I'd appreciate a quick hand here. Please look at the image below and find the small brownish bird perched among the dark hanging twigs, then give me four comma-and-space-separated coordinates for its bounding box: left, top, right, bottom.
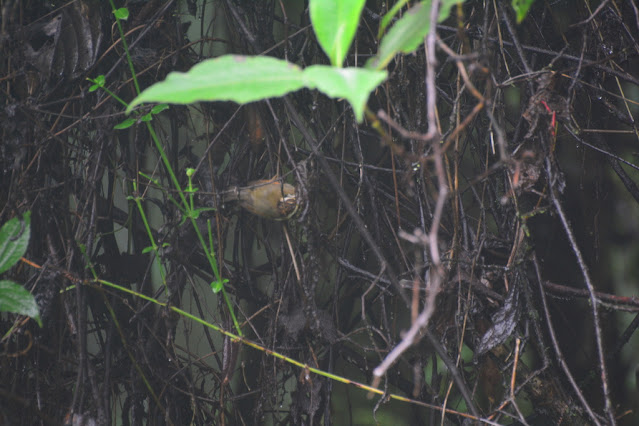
223, 178, 299, 220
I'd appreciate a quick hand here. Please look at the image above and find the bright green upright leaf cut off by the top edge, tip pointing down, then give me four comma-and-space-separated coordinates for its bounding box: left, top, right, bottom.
309, 0, 366, 67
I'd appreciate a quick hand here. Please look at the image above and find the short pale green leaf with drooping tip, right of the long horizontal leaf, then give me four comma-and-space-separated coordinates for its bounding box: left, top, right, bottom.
304, 65, 387, 122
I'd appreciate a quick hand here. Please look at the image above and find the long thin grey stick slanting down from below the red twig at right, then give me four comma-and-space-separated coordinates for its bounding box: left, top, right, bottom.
546, 158, 616, 425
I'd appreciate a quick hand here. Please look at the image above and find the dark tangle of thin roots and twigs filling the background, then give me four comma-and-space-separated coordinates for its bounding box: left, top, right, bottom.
0, 0, 639, 425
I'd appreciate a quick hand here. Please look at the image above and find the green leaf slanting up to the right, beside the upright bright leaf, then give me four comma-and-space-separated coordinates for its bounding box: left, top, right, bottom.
366, 0, 461, 69
